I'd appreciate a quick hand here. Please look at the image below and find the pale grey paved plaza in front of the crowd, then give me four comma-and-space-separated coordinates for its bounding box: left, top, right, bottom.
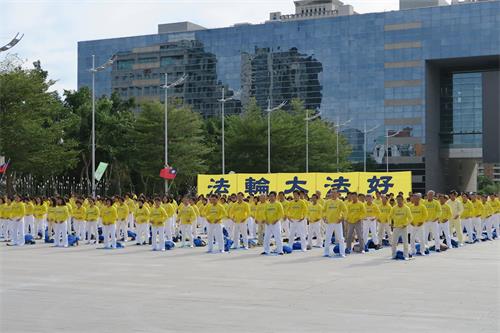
0, 241, 500, 333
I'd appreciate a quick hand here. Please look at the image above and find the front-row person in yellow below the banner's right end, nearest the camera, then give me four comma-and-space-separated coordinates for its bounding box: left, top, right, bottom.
390, 195, 413, 260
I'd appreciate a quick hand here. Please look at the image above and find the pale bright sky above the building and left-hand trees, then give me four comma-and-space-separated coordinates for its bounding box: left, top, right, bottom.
0, 0, 399, 92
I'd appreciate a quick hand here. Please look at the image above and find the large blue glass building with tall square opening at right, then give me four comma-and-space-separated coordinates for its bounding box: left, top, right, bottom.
78, 0, 500, 191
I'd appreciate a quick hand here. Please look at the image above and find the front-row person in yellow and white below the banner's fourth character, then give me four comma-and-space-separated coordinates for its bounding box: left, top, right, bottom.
323, 190, 347, 257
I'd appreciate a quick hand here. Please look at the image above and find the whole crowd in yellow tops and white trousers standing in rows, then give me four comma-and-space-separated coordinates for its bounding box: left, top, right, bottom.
0, 190, 500, 260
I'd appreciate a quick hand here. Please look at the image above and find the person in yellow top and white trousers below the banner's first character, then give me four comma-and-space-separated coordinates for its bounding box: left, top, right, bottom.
205, 194, 227, 253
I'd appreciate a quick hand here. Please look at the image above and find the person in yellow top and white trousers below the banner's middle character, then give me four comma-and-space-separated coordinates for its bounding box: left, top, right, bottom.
286, 191, 307, 251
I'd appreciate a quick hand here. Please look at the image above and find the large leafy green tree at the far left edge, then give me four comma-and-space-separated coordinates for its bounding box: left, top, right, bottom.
0, 62, 78, 192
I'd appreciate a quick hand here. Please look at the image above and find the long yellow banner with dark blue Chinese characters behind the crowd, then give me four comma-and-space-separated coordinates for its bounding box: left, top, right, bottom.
198, 171, 412, 196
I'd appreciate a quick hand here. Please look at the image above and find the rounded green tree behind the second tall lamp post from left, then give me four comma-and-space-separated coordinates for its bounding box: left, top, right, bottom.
132, 101, 210, 193
